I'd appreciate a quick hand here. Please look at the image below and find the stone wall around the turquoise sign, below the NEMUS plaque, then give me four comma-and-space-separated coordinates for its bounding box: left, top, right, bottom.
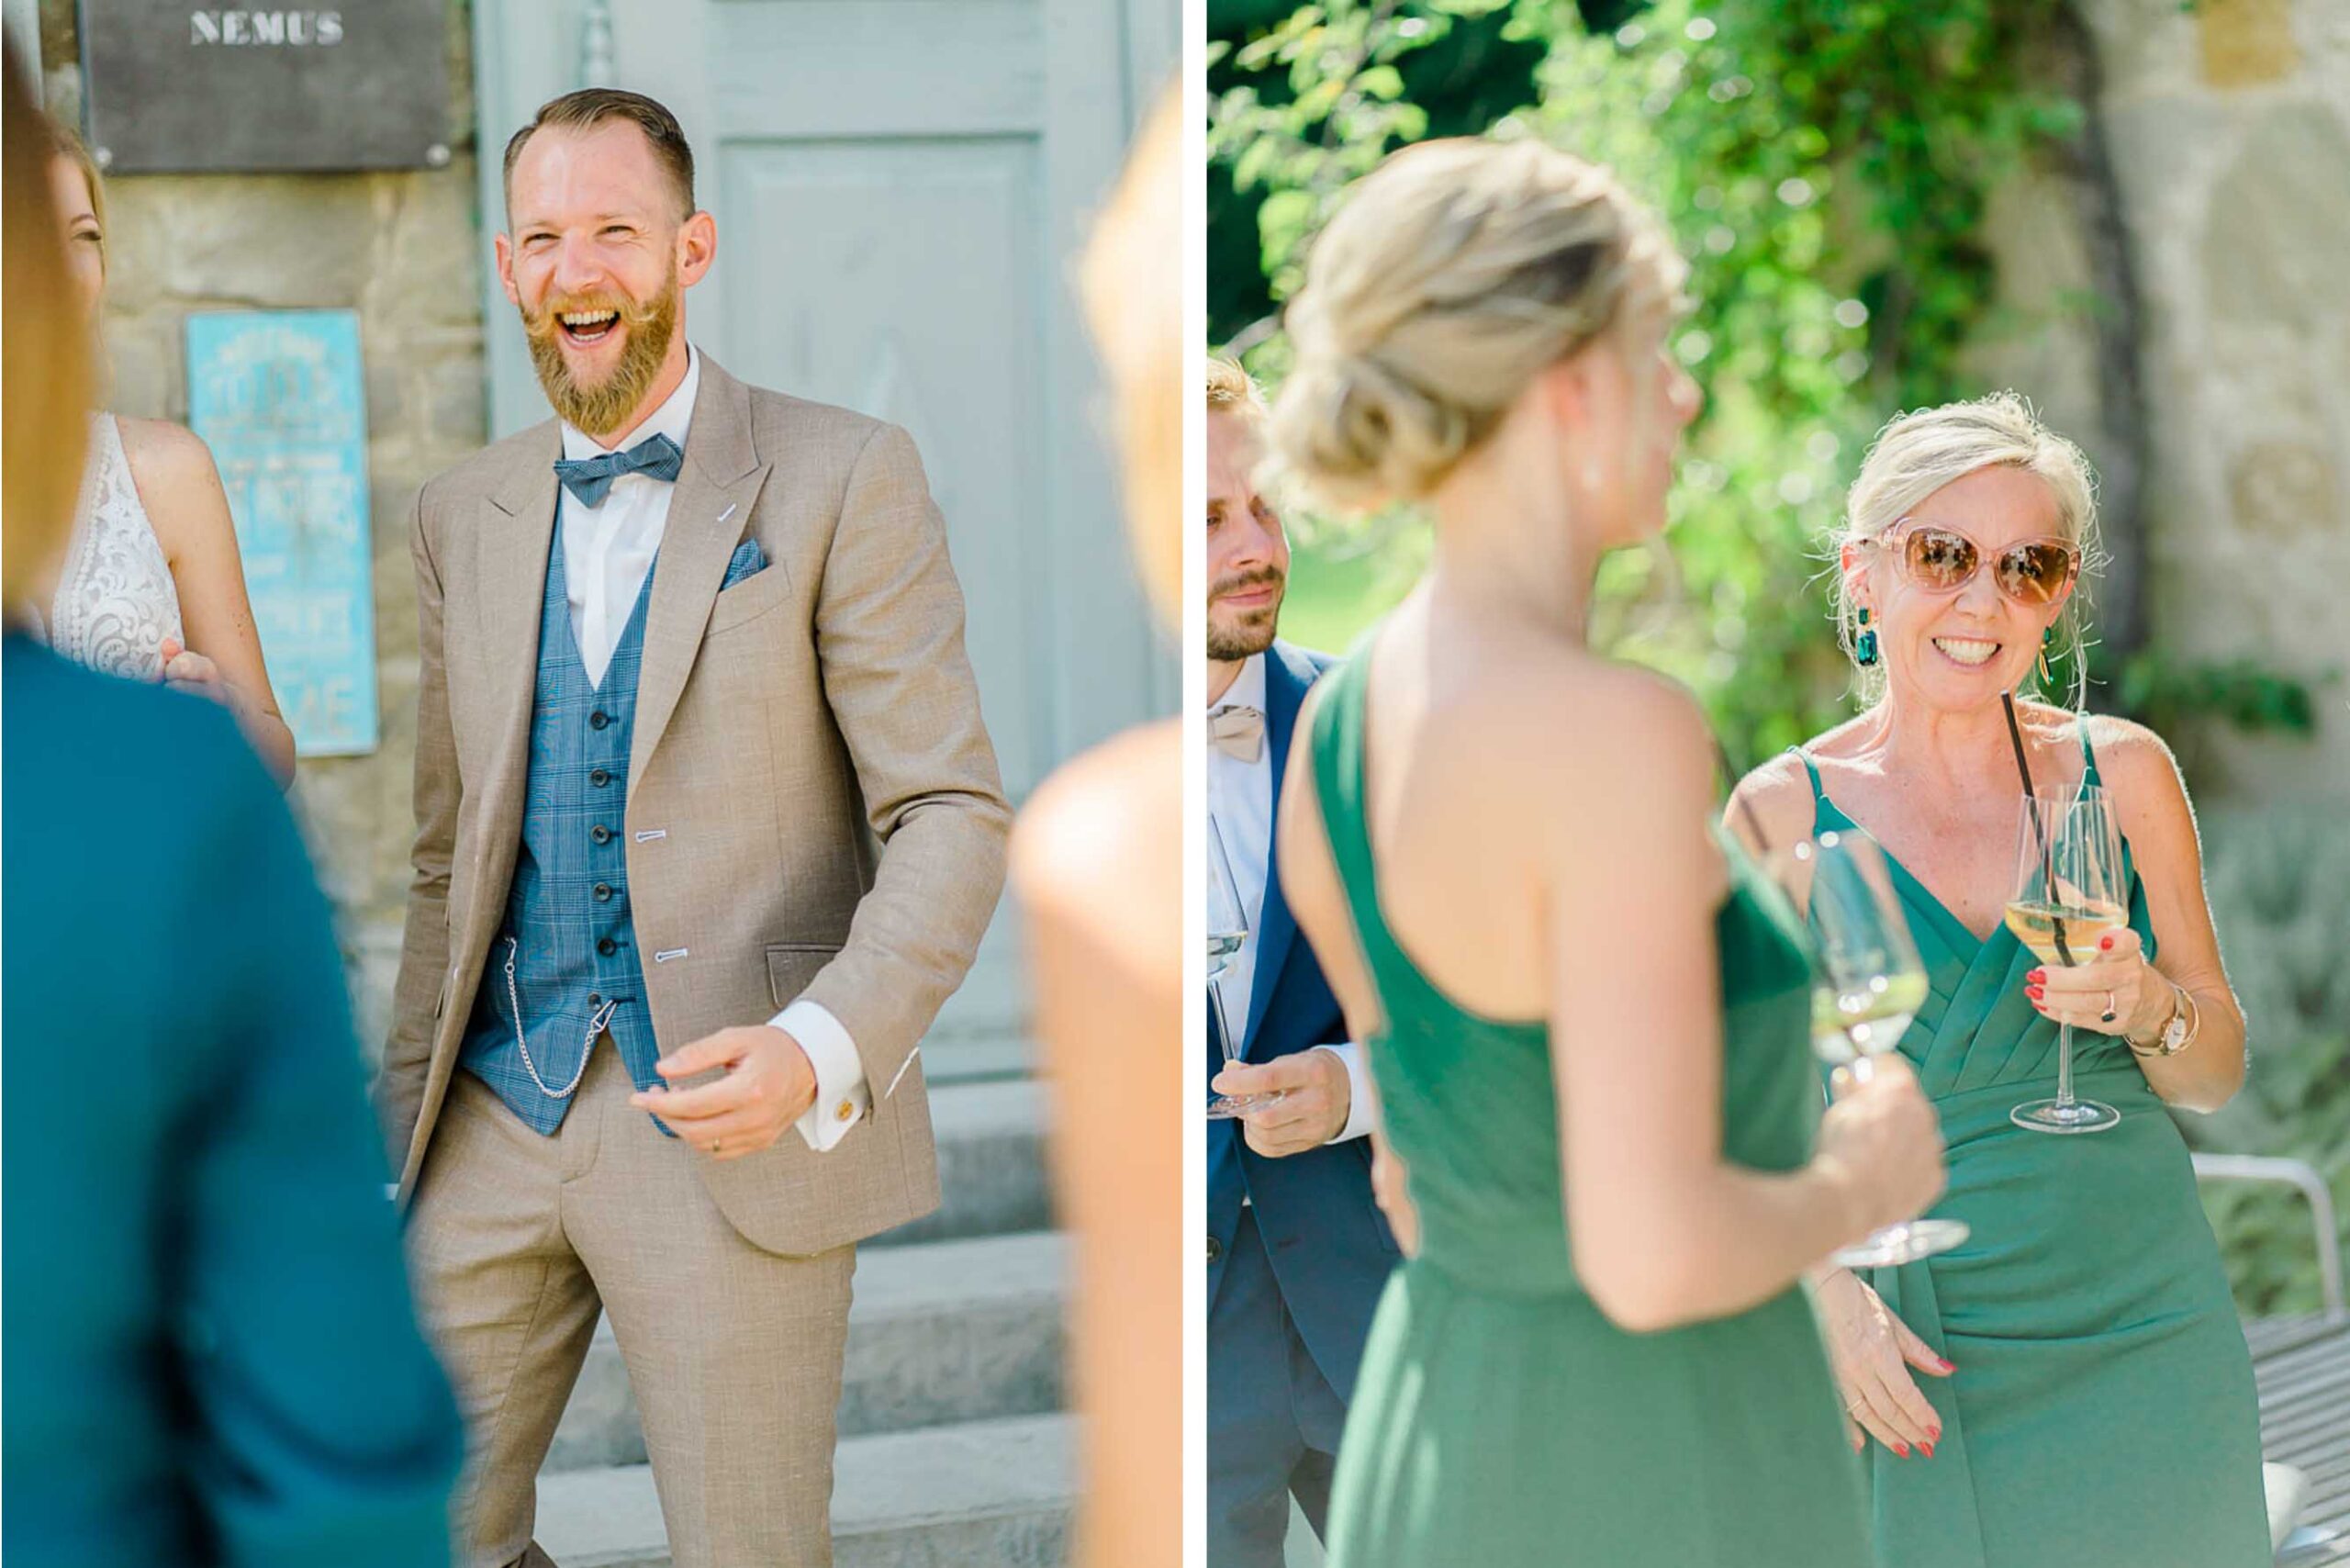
40, 0, 488, 1051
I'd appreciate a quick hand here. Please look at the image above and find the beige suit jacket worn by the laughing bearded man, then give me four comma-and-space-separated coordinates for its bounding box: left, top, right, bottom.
378, 355, 1011, 1255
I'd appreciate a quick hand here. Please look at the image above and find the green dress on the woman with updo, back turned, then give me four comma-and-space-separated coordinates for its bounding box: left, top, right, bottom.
1311, 655, 1868, 1568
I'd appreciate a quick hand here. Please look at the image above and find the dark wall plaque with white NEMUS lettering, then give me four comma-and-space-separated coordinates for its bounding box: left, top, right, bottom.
80, 0, 449, 174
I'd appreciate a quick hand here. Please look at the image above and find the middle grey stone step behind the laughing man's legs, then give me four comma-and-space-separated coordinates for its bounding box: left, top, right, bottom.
545, 1232, 1069, 1472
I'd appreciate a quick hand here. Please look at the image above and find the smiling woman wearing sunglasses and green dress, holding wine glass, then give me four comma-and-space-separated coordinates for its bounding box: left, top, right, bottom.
1729, 393, 2270, 1568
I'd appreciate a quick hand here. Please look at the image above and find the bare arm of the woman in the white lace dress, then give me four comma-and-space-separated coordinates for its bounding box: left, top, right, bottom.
120, 419, 294, 790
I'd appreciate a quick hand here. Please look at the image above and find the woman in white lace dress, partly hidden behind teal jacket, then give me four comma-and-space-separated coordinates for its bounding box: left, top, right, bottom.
28, 120, 294, 788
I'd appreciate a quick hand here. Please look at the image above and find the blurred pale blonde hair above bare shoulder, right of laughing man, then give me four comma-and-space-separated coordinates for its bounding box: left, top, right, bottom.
1079, 87, 1184, 625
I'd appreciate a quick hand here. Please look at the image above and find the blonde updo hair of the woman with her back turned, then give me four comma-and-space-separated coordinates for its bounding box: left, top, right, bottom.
1271, 139, 1687, 510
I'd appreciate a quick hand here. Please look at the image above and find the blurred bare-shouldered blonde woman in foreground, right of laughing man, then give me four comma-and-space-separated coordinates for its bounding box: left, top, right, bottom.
1013, 89, 1192, 1568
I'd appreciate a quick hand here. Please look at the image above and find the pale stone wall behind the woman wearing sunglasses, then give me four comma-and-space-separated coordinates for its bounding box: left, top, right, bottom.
1979, 0, 2350, 804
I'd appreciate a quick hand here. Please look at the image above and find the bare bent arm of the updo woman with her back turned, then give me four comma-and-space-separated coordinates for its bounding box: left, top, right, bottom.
1528, 672, 1942, 1330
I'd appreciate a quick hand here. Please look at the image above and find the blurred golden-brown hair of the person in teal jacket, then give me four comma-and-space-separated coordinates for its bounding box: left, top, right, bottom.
0, 47, 89, 613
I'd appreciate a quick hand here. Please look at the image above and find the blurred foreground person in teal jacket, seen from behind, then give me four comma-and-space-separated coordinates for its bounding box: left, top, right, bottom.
0, 50, 461, 1568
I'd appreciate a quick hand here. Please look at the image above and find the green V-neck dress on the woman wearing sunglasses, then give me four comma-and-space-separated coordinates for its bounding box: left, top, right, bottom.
1797, 734, 2270, 1568
